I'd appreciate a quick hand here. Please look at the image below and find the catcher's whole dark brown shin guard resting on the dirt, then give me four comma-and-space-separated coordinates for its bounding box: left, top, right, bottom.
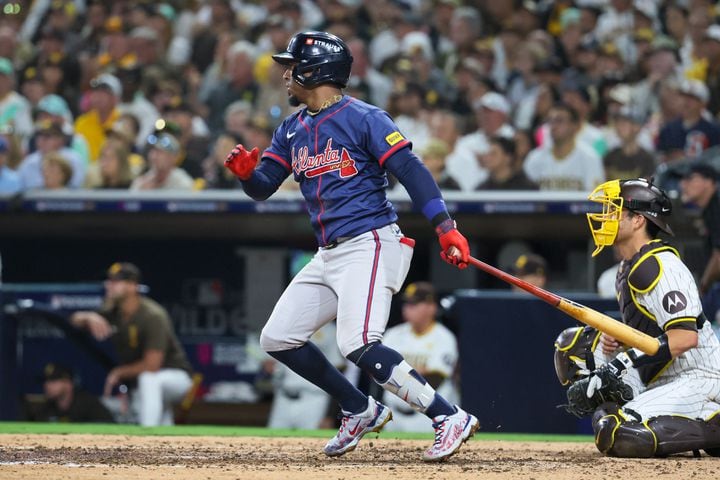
593, 412, 720, 458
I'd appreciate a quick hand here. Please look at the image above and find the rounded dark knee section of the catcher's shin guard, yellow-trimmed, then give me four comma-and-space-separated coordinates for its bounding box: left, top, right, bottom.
593, 412, 657, 458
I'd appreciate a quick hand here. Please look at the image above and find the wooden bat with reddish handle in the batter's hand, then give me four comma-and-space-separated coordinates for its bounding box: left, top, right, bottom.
469, 256, 660, 355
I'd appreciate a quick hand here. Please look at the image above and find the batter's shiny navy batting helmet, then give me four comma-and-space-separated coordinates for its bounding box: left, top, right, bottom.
273, 31, 353, 88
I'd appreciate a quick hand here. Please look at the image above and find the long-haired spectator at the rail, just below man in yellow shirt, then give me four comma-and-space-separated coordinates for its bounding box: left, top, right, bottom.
85, 141, 135, 189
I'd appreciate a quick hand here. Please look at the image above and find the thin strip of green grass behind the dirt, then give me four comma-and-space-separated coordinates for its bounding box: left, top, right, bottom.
0, 422, 593, 442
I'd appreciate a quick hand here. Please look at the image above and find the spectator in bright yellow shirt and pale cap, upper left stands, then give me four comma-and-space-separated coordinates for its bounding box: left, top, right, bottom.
75, 73, 122, 162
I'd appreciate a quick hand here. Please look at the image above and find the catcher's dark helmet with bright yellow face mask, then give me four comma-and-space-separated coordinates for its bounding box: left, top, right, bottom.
587, 178, 673, 257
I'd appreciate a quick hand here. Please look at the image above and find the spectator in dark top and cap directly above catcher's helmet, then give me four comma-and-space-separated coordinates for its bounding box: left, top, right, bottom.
603, 105, 656, 179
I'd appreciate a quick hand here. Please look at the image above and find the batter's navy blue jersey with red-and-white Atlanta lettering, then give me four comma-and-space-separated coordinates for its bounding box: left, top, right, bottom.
263, 95, 411, 246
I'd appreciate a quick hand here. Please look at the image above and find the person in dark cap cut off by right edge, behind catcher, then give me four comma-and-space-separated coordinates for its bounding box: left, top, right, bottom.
680, 163, 720, 295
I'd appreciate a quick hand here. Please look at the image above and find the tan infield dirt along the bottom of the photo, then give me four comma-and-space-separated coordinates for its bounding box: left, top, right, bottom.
0, 435, 720, 480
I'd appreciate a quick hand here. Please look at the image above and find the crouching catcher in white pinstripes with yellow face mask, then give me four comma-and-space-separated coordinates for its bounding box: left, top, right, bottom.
555, 178, 720, 457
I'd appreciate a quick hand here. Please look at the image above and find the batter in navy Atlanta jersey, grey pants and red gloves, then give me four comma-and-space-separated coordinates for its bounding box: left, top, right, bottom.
225, 32, 479, 461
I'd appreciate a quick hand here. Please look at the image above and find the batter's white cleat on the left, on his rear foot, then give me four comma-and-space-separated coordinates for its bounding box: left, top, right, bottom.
323, 397, 392, 457
